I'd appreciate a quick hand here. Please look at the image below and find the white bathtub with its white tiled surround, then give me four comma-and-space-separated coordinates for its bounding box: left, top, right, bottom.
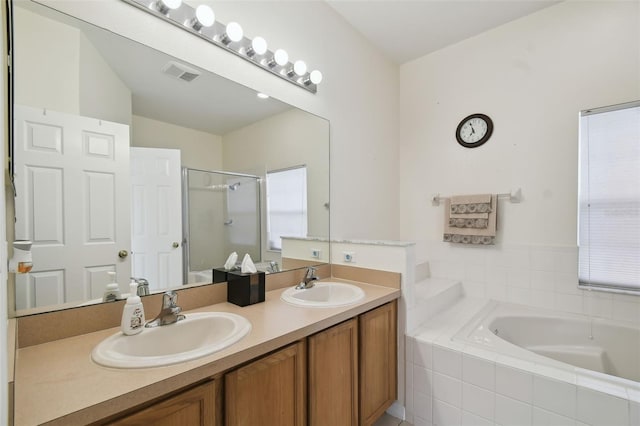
405, 291, 640, 426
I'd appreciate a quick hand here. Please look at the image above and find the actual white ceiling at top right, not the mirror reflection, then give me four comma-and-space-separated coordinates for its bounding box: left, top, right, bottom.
325, 0, 559, 64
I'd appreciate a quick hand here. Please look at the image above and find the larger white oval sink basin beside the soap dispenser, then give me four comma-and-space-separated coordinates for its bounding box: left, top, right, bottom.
91, 312, 251, 368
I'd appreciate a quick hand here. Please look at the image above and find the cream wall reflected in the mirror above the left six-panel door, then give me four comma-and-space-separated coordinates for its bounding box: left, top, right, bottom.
14, 7, 131, 124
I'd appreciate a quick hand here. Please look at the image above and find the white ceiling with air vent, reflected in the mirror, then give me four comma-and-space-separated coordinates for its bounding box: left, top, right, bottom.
84, 26, 292, 135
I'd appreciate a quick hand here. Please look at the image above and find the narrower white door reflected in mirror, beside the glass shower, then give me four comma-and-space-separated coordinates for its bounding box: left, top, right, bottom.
131, 147, 183, 290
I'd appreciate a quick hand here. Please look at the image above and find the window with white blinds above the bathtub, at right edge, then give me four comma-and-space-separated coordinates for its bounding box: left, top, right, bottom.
578, 101, 640, 292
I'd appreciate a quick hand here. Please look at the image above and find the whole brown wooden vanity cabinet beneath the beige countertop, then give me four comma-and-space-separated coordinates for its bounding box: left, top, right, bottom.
99, 301, 397, 426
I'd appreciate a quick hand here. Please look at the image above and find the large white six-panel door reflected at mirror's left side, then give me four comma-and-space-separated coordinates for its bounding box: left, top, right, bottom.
14, 105, 131, 309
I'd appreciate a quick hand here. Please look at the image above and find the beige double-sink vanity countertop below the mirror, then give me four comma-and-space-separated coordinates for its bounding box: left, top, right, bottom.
14, 280, 400, 426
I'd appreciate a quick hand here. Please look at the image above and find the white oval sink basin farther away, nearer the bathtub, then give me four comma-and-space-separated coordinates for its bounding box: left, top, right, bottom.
281, 281, 364, 308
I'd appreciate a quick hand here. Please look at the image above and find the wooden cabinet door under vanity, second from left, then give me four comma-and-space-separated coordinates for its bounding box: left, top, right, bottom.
225, 341, 307, 426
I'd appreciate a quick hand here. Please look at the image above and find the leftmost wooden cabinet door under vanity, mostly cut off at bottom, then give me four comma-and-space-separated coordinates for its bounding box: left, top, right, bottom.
111, 380, 219, 426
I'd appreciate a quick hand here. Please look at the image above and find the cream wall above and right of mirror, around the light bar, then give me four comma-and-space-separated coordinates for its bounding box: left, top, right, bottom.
35, 0, 399, 239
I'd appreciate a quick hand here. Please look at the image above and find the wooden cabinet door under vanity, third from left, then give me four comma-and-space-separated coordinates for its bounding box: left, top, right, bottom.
308, 318, 358, 426
